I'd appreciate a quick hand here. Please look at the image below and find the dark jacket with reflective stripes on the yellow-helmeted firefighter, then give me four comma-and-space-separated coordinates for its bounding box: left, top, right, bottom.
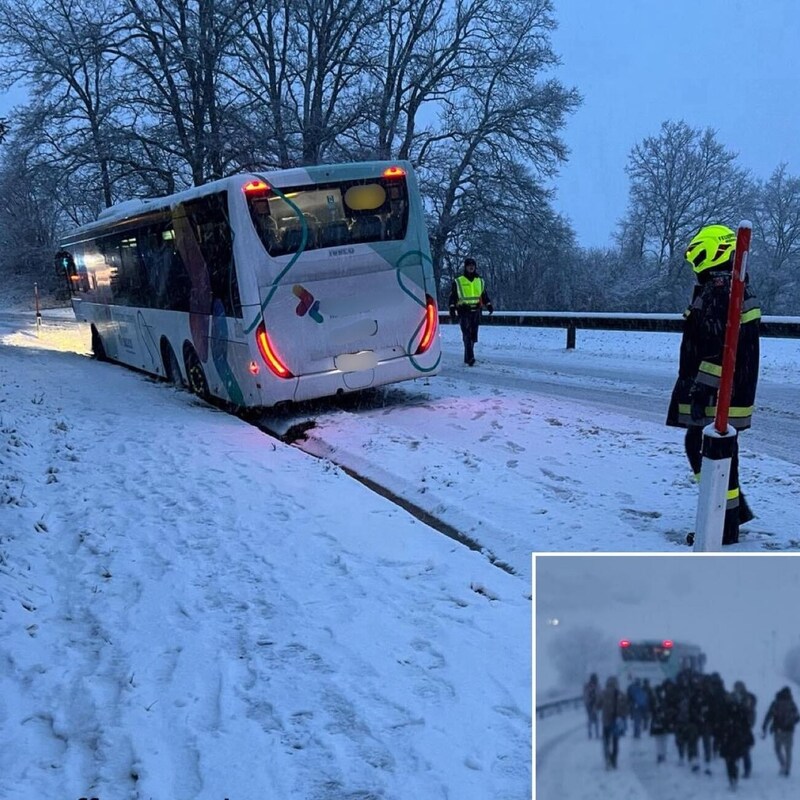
667, 270, 761, 430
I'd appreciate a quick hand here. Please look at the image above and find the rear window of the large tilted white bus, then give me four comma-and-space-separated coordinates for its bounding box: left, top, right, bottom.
247, 178, 408, 256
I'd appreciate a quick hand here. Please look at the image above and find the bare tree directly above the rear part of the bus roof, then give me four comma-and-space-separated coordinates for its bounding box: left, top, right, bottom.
229, 0, 388, 167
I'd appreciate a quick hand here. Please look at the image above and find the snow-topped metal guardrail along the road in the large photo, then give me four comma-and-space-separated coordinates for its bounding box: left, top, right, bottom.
439, 311, 800, 350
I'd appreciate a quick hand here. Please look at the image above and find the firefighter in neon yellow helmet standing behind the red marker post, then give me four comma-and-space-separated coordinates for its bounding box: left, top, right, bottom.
667, 225, 761, 544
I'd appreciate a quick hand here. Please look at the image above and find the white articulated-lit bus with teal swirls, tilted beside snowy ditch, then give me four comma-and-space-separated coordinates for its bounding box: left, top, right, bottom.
56, 161, 441, 409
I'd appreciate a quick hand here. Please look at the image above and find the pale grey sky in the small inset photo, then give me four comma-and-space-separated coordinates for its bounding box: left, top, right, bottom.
536, 554, 800, 692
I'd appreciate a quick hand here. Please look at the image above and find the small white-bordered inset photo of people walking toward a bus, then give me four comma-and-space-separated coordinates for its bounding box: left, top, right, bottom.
533, 553, 800, 800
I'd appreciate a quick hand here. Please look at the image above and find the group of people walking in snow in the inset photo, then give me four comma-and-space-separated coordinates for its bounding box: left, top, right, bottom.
583, 670, 800, 789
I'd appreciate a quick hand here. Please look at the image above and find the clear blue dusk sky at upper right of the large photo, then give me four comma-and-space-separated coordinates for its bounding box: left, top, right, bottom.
553, 0, 800, 246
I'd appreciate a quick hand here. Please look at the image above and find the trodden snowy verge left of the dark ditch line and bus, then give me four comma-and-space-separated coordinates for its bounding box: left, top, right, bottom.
0, 310, 531, 800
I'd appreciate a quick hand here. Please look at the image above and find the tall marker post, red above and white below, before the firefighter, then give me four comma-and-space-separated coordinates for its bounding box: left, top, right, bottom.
694, 220, 753, 552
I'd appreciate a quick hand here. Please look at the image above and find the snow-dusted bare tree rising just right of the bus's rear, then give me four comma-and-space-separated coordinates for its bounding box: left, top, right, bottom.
417, 0, 580, 296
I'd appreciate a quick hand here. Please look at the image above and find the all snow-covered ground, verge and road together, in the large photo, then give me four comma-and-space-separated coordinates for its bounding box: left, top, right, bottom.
0, 310, 800, 800
